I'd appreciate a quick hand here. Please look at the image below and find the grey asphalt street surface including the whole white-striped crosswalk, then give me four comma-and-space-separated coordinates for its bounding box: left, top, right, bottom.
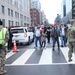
5, 40, 75, 75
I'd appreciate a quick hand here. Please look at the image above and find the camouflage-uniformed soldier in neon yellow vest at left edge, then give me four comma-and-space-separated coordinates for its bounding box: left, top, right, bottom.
0, 20, 9, 74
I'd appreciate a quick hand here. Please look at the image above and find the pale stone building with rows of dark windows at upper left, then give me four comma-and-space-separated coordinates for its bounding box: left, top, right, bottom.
0, 0, 31, 27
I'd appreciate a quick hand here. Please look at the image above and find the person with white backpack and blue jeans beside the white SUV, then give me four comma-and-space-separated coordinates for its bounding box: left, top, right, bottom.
35, 25, 42, 48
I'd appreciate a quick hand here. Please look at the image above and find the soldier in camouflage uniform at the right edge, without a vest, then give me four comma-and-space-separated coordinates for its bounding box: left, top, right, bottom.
67, 19, 75, 62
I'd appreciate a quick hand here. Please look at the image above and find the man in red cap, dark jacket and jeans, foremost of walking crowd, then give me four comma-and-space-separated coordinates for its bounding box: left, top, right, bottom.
51, 24, 60, 51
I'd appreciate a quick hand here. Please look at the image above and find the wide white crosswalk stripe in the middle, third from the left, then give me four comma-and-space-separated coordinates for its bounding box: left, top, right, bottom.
39, 48, 52, 64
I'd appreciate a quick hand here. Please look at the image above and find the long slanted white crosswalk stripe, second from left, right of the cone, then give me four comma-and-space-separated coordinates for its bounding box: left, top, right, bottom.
11, 49, 34, 65
